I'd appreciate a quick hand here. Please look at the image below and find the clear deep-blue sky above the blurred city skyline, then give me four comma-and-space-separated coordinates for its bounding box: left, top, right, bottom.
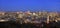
0, 0, 60, 11
